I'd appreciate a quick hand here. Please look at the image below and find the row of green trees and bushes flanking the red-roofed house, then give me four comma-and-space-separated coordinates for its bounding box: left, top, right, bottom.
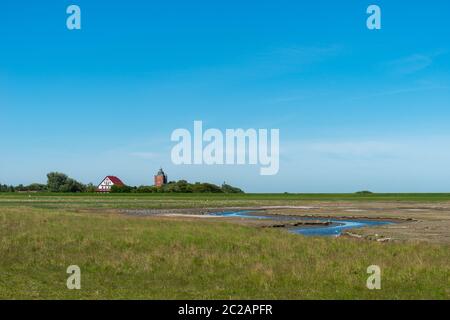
0, 172, 244, 193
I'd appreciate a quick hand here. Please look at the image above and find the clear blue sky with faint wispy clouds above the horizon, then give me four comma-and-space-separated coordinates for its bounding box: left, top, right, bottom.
0, 0, 450, 192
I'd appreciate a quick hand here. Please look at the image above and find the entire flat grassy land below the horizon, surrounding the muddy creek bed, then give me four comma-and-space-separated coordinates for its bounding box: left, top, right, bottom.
0, 194, 450, 299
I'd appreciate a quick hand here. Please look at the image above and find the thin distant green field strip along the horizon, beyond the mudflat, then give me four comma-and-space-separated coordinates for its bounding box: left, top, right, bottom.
0, 193, 450, 209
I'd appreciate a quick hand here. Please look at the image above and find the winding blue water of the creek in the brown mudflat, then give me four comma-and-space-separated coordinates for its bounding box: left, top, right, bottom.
212, 210, 392, 237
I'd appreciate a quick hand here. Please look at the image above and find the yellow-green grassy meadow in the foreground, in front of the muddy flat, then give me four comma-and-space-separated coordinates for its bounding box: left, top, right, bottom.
0, 206, 450, 299
